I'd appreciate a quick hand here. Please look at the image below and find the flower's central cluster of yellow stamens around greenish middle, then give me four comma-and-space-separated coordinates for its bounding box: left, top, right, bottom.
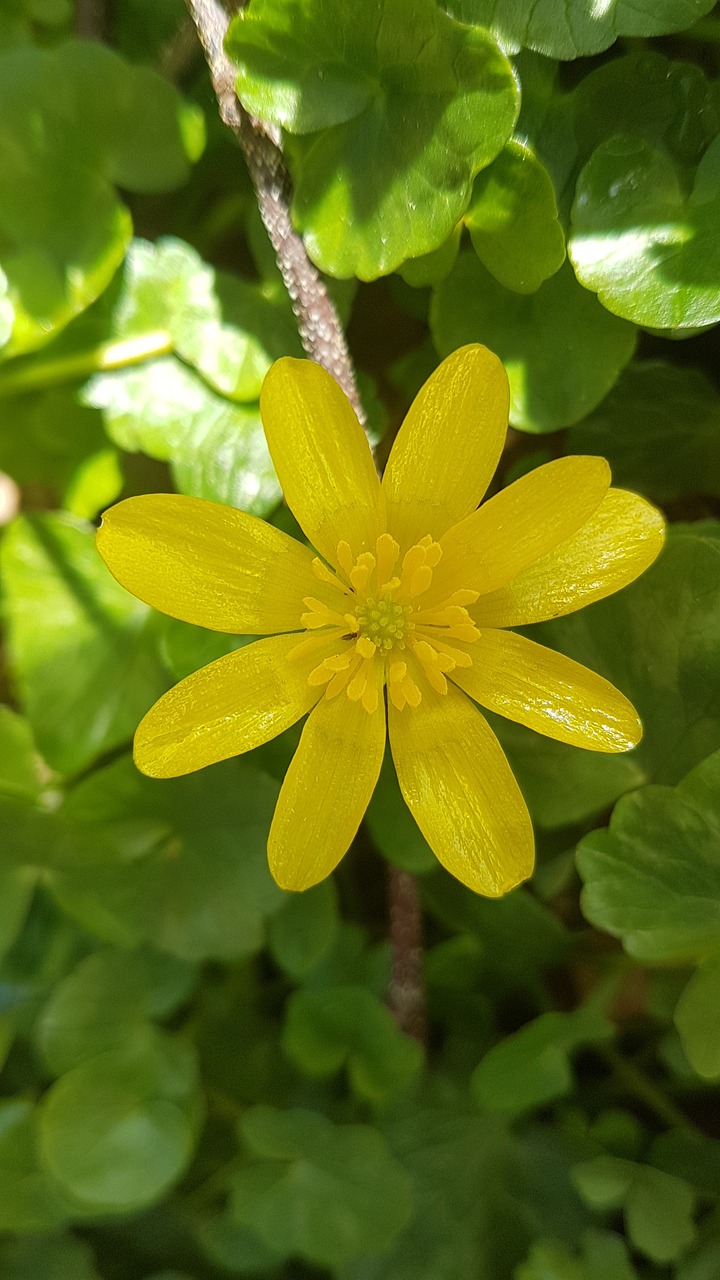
293, 534, 479, 713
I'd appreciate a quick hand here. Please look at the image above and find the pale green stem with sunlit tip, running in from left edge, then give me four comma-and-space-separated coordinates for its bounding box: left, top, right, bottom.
0, 329, 173, 399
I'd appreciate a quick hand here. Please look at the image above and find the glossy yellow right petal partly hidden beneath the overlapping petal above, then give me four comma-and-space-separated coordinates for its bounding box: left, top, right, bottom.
470, 489, 665, 627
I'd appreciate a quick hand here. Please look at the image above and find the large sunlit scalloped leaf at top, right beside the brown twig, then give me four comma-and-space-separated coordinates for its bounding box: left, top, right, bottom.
228, 0, 518, 280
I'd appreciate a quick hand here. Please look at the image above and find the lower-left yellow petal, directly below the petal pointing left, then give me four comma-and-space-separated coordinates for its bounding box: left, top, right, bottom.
135, 635, 325, 778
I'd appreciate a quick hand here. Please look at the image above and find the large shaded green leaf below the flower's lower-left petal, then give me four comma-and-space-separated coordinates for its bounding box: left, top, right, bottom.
51, 758, 282, 960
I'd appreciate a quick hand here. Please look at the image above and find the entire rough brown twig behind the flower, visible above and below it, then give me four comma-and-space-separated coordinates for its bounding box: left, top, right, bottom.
187, 0, 425, 1043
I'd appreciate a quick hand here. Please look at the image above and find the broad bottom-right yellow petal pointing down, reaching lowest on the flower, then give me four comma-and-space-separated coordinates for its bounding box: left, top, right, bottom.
388, 685, 534, 897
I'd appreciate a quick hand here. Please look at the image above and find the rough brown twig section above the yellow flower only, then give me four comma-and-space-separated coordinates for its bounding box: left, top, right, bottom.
187, 0, 365, 422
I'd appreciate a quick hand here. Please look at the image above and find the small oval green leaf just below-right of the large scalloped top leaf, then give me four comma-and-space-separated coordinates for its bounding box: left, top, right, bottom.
464, 141, 565, 293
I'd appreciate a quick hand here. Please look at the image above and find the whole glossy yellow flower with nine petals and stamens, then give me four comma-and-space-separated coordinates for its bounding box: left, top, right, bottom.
97, 346, 664, 897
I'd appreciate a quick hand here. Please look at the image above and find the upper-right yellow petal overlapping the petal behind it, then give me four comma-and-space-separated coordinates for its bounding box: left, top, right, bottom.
433, 457, 610, 593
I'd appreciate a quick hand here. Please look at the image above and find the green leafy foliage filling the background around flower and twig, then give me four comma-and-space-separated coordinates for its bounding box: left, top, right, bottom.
0, 0, 720, 1280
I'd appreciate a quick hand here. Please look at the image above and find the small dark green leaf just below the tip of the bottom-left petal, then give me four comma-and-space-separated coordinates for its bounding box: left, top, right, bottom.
268, 879, 340, 978
